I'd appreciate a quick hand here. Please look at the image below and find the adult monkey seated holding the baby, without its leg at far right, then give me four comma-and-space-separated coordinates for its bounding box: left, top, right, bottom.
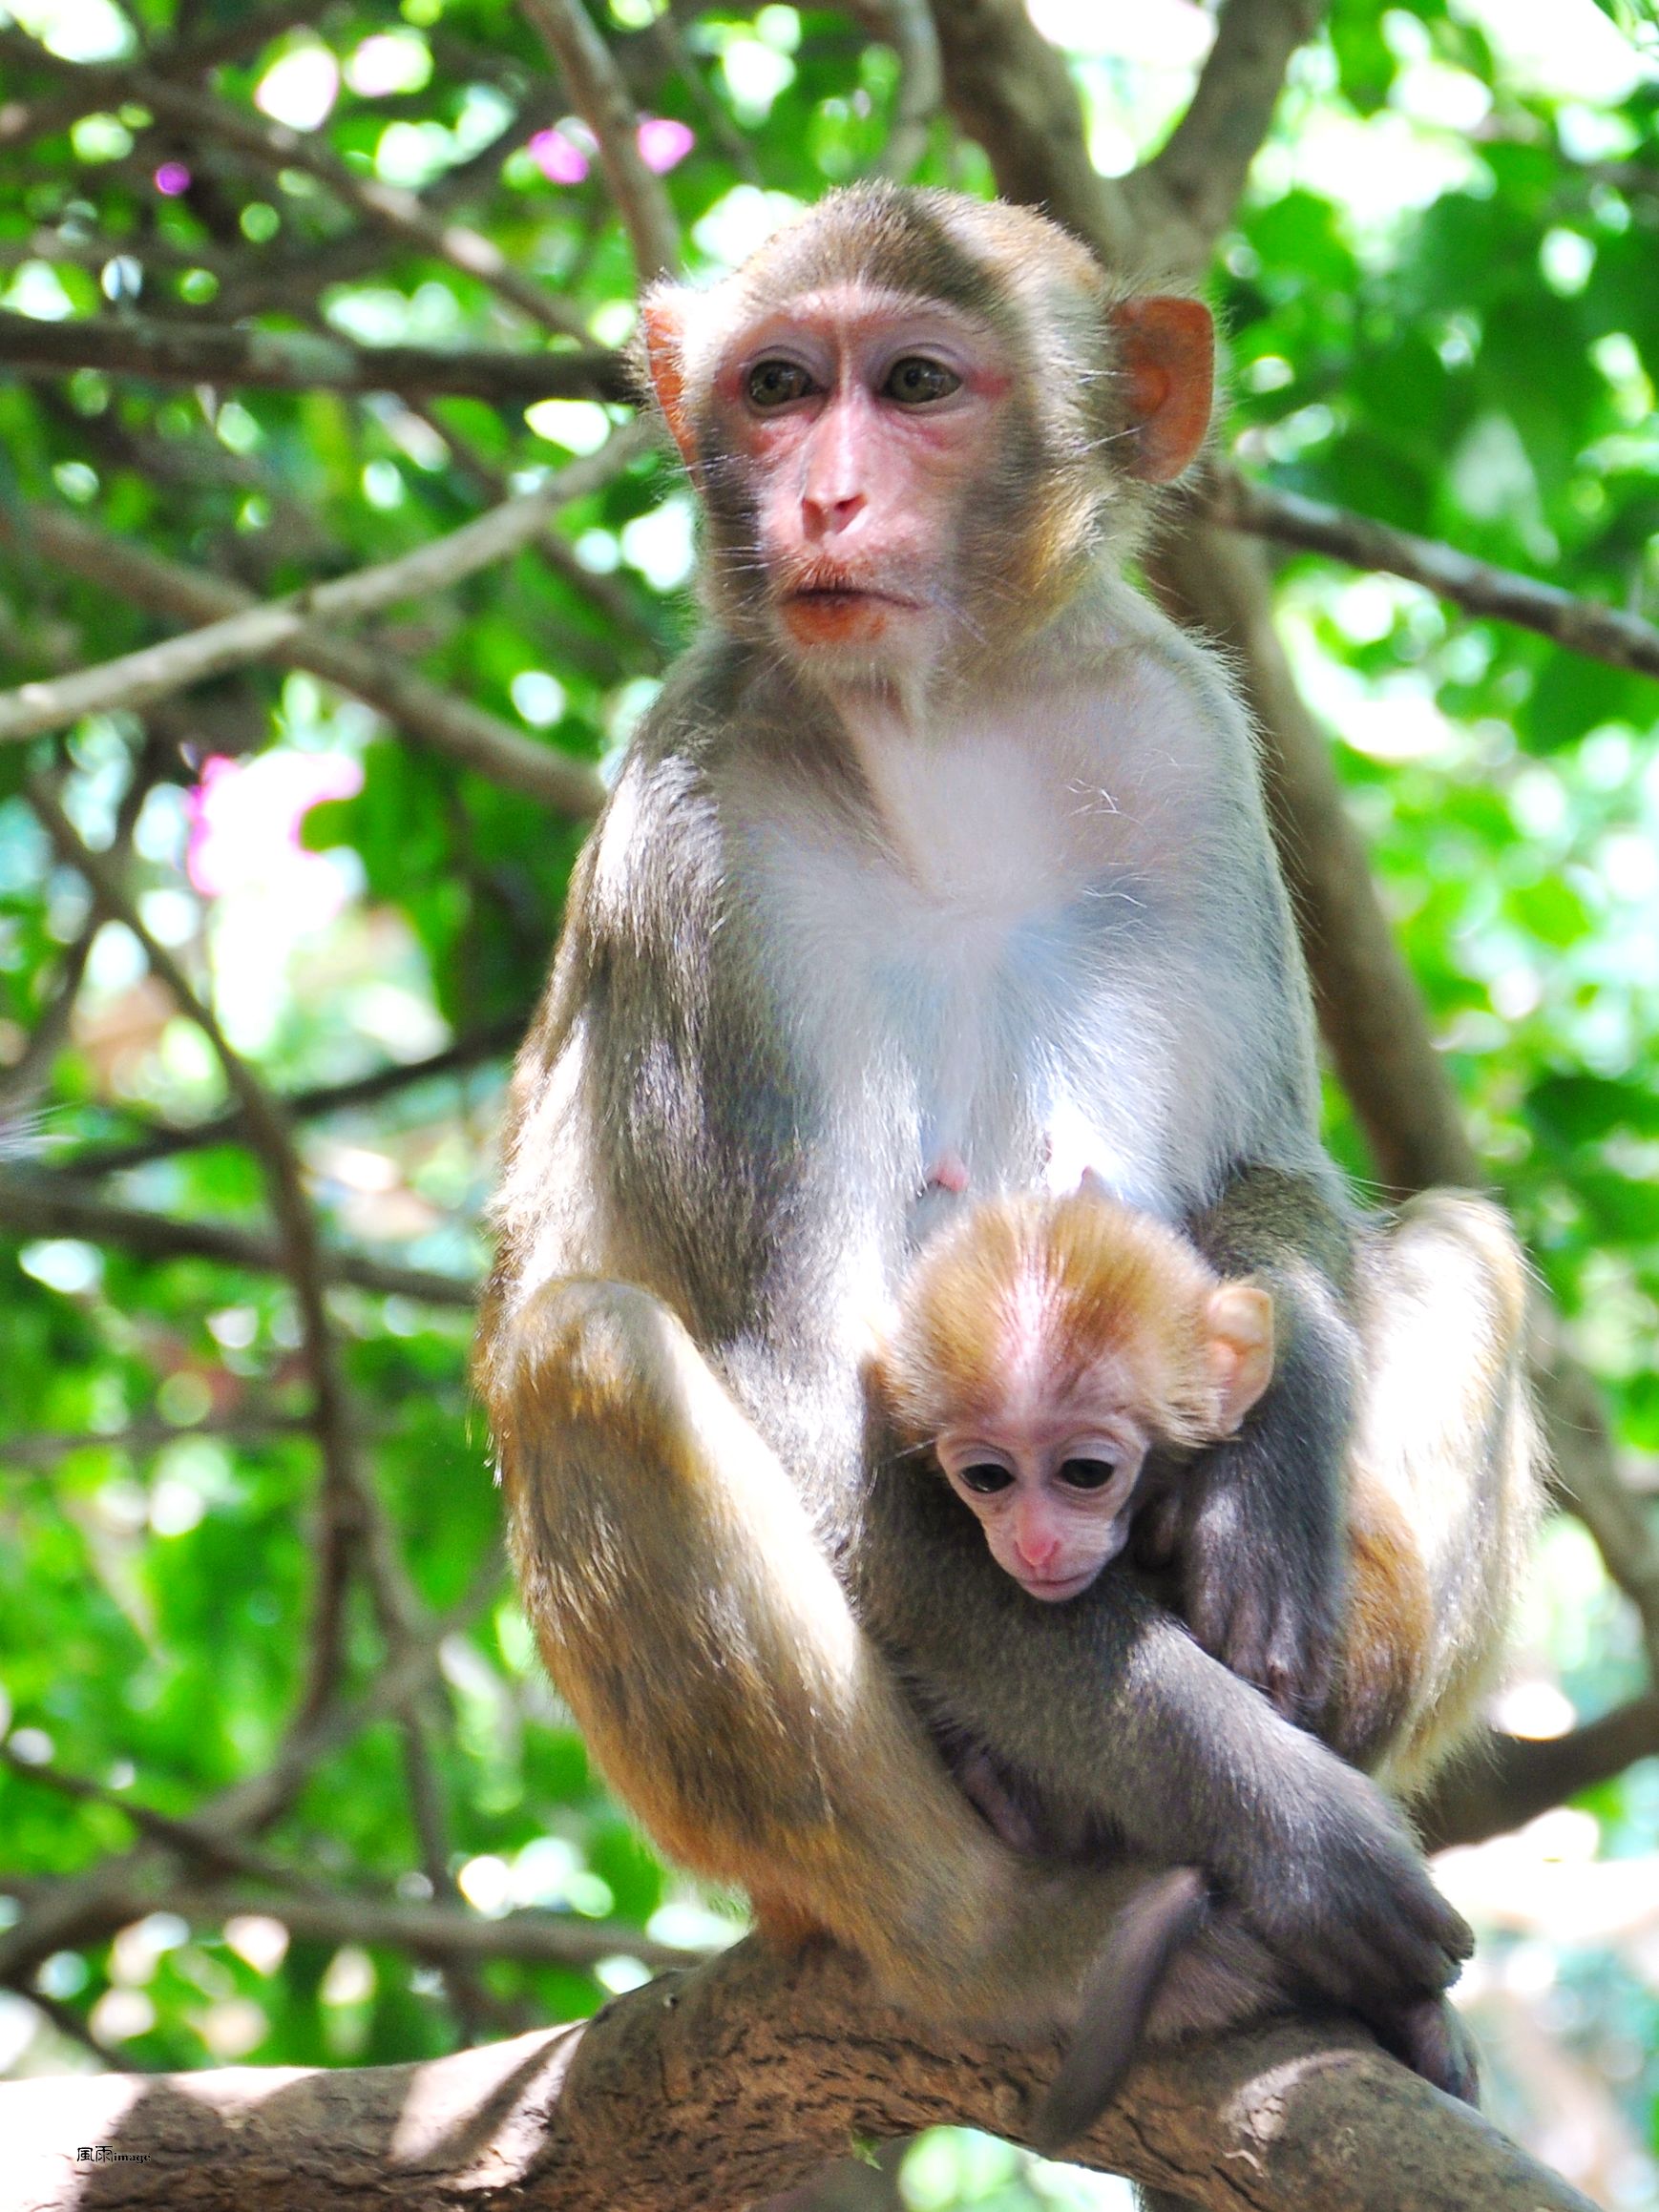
478, 186, 1466, 2123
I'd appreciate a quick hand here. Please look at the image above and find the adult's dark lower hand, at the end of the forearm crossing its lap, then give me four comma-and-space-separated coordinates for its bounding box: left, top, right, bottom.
1228, 1739, 1476, 2048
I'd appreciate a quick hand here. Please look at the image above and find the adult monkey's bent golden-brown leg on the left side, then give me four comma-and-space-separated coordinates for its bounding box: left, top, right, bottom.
487, 1281, 1128, 2029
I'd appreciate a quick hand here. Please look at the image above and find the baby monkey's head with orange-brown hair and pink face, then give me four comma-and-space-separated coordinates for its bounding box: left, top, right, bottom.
876, 1175, 1274, 1604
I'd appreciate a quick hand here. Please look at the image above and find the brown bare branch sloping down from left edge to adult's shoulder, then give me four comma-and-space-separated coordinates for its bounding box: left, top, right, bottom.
0, 507, 604, 821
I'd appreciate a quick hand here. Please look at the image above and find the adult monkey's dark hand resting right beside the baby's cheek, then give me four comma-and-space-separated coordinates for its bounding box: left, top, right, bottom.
1137, 1445, 1343, 1727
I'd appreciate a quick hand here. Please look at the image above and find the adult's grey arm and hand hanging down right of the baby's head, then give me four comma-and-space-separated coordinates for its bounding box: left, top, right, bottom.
1142, 1168, 1360, 1727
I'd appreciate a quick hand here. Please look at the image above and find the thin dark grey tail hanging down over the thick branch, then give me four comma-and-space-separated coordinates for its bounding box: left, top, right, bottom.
1031, 1867, 1210, 2159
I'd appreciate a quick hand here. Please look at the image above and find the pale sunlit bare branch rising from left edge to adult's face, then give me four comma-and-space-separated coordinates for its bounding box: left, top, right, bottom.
0, 423, 650, 741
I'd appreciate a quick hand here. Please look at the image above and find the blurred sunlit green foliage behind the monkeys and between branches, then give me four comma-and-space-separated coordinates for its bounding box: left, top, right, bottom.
0, 0, 1659, 2212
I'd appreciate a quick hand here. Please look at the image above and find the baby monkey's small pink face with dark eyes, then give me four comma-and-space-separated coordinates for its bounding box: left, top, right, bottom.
934, 1420, 1145, 1604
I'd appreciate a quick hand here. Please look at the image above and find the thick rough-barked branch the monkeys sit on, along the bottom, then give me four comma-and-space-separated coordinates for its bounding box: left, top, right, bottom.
0, 1942, 1592, 2212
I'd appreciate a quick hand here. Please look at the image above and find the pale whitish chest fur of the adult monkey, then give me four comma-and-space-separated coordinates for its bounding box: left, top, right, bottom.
739, 657, 1266, 1212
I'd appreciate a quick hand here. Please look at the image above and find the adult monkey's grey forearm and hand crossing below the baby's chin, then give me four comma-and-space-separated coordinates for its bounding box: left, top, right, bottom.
863, 1465, 1469, 2024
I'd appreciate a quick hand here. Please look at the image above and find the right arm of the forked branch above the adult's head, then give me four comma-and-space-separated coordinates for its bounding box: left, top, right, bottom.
1126, 0, 1327, 252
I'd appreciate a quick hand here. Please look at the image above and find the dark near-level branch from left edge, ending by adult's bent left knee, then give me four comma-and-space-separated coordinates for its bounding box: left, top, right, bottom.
0, 1168, 478, 1312
